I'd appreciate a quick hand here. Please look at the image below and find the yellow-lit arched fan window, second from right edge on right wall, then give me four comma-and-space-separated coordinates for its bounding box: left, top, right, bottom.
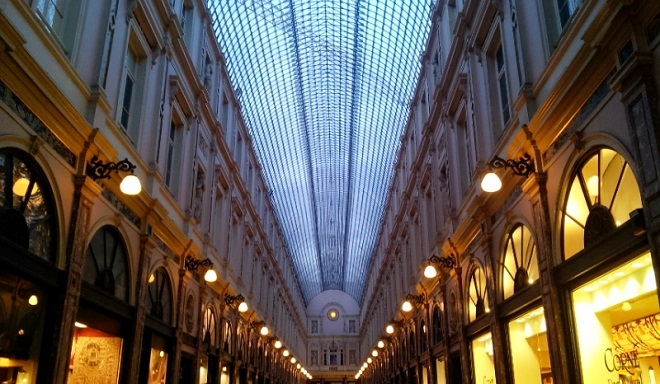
502, 225, 539, 299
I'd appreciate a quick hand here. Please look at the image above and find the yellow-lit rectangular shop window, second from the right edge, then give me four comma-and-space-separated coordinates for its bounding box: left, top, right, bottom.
509, 307, 548, 384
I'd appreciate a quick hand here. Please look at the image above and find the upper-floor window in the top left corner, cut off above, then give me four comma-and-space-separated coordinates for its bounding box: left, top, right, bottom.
36, 0, 82, 57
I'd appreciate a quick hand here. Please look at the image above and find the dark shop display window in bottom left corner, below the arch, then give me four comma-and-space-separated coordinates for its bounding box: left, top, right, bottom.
0, 271, 47, 383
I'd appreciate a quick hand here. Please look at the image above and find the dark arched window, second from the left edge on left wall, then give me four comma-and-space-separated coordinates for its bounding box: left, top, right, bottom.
83, 225, 128, 301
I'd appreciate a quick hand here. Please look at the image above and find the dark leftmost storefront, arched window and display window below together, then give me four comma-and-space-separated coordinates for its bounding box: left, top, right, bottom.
0, 148, 63, 383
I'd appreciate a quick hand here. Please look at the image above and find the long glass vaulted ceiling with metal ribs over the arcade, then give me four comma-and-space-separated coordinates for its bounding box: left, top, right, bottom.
208, 0, 433, 303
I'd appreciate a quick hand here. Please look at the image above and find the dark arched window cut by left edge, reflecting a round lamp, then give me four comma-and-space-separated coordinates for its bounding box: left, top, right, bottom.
0, 148, 57, 261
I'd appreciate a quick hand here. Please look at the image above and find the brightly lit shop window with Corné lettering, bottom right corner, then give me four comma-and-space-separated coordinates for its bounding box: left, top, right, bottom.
572, 252, 660, 383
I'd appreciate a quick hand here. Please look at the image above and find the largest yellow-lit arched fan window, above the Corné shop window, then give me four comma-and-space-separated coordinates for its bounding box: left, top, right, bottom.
562, 148, 642, 259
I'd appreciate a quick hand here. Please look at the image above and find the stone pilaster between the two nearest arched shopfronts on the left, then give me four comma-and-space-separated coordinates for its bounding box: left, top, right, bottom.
51, 176, 101, 384
